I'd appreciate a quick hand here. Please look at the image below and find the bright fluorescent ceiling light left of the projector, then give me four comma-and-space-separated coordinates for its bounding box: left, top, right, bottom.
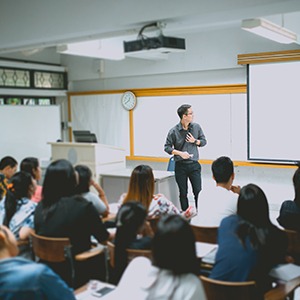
56, 38, 125, 60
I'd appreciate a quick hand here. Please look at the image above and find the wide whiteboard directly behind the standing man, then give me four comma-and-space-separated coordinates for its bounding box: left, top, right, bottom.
134, 94, 247, 160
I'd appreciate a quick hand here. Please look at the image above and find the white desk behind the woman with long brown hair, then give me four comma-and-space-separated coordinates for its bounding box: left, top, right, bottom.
100, 168, 181, 209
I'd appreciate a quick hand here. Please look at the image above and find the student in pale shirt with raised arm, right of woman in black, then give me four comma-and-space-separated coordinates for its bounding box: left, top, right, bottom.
75, 165, 109, 217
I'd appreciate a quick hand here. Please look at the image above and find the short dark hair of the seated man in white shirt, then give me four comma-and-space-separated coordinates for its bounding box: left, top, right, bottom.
211, 156, 233, 183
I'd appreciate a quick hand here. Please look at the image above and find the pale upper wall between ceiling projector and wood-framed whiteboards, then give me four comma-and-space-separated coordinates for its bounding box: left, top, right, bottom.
61, 28, 300, 91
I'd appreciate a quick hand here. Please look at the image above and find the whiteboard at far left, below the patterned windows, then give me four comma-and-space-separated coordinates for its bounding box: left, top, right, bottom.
0, 105, 61, 163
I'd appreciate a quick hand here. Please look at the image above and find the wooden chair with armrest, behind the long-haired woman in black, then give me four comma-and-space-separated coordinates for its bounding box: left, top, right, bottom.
30, 233, 104, 287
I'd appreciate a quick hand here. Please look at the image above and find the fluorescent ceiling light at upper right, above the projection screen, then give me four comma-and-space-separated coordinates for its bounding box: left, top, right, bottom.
242, 19, 298, 44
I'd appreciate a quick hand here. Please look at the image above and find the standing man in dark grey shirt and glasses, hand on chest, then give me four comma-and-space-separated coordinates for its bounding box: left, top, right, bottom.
165, 104, 206, 211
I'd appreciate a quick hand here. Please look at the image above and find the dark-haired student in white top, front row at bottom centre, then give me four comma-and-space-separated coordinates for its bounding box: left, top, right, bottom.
105, 215, 206, 300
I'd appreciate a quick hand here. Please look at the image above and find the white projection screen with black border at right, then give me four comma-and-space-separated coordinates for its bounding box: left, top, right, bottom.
248, 62, 300, 163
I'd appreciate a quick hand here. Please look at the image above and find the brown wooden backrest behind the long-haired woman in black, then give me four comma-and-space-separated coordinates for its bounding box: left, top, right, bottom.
30, 233, 71, 263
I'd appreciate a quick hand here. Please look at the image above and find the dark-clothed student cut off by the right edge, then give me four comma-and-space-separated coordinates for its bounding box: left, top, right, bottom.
277, 165, 300, 231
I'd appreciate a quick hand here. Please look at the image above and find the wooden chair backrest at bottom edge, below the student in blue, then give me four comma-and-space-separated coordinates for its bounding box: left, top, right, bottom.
200, 276, 258, 300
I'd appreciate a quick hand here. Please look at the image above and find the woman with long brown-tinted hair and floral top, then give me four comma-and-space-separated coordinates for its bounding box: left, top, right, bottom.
119, 165, 196, 219
